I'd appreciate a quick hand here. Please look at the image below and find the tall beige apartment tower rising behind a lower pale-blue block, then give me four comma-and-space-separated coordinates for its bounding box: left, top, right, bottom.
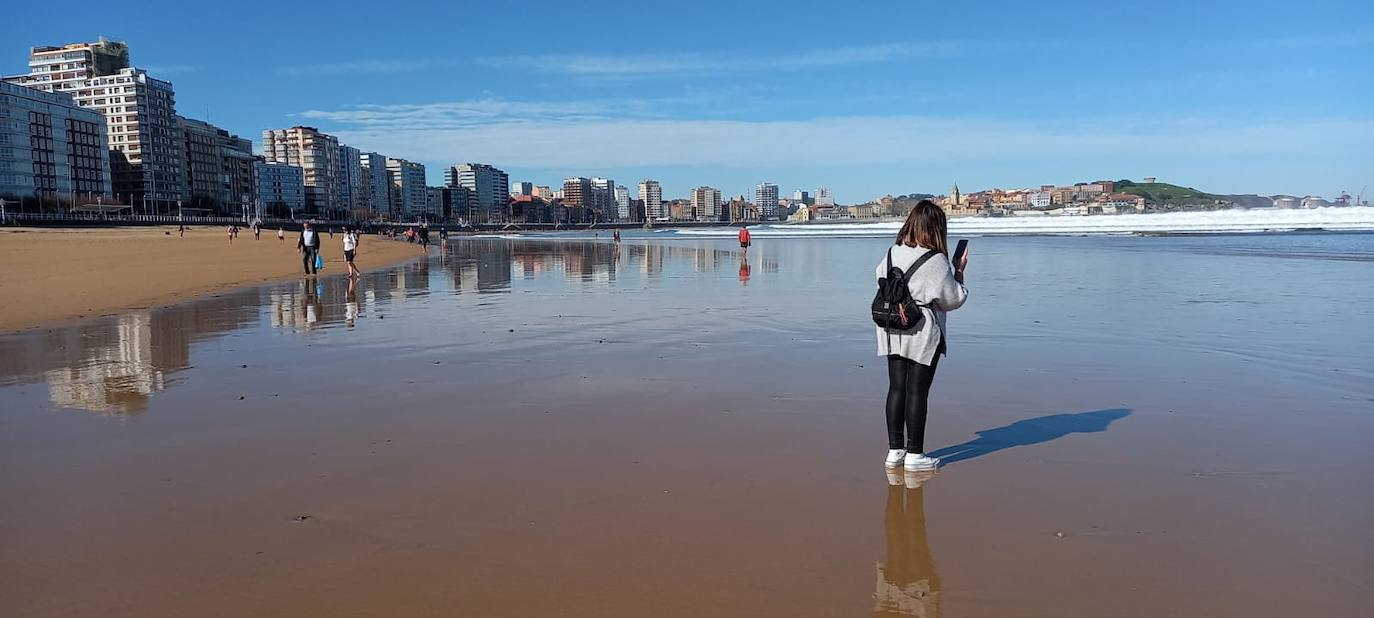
262, 126, 344, 217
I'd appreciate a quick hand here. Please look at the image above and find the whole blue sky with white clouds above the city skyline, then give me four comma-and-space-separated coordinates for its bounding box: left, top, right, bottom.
0, 0, 1374, 203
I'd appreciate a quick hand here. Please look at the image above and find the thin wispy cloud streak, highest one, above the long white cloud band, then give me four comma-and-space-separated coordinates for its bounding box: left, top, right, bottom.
477, 41, 967, 78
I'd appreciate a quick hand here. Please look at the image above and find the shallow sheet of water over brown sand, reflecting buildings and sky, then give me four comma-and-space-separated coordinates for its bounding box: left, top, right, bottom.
0, 233, 1374, 615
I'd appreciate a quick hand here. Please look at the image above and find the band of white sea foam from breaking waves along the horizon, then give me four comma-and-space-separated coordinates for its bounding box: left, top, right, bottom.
672, 207, 1374, 236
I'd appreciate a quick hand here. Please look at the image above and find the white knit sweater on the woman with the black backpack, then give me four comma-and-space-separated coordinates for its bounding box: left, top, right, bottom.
874, 244, 969, 365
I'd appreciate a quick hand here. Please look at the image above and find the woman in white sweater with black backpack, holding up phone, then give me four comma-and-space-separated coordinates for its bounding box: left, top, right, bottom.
875, 199, 969, 471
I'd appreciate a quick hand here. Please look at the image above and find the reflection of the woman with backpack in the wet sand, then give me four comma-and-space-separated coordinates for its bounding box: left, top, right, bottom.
872, 471, 940, 618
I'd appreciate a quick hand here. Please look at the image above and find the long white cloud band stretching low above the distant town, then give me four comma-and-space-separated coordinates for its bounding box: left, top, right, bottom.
321, 113, 1374, 169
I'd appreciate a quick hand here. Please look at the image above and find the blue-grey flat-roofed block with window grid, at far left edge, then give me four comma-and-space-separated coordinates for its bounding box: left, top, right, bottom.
0, 82, 113, 202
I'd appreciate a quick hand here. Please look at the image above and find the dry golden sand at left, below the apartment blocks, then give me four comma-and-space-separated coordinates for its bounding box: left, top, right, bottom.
0, 227, 420, 332
